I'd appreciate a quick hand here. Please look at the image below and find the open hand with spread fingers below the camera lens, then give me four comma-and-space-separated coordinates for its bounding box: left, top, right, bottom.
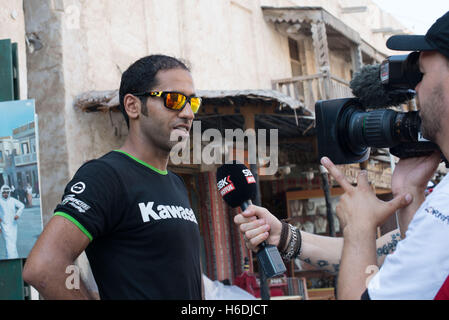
321, 157, 412, 235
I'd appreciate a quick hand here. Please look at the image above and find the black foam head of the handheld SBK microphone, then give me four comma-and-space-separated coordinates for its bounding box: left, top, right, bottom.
217, 161, 257, 208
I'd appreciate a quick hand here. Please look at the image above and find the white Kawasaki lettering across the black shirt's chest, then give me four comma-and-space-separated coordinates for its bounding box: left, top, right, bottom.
139, 202, 198, 224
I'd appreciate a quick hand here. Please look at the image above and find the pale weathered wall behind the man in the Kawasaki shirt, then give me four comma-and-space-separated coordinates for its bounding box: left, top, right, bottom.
20, 0, 406, 223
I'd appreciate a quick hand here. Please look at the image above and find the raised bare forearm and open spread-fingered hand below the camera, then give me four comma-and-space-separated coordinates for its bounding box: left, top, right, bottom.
321, 158, 412, 299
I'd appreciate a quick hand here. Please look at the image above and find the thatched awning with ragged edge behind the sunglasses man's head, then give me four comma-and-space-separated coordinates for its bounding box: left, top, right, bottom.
74, 90, 315, 137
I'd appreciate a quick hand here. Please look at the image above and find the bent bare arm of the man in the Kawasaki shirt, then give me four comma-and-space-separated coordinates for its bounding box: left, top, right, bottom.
23, 216, 92, 300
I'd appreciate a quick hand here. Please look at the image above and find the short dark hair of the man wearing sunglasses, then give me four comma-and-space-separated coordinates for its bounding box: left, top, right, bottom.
119, 54, 190, 128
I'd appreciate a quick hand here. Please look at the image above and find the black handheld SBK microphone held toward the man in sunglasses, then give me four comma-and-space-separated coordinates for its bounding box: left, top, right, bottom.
217, 161, 287, 278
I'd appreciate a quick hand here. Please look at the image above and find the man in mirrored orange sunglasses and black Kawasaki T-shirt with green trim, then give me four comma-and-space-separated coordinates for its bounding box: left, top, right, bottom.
23, 55, 202, 300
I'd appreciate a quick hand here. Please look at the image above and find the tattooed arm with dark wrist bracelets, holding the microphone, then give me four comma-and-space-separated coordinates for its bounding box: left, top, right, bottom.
234, 205, 400, 274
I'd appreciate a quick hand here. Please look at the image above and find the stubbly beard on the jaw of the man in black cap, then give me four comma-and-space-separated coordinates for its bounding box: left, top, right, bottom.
418, 85, 445, 143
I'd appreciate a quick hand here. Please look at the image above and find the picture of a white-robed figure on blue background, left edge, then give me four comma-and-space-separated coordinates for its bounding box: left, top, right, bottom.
0, 100, 42, 260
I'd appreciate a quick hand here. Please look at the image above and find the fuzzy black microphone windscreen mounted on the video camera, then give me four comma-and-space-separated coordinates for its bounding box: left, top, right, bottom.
349, 64, 414, 109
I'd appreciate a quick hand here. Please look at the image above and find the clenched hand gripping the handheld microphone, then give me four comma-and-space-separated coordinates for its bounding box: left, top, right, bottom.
234, 205, 282, 251
